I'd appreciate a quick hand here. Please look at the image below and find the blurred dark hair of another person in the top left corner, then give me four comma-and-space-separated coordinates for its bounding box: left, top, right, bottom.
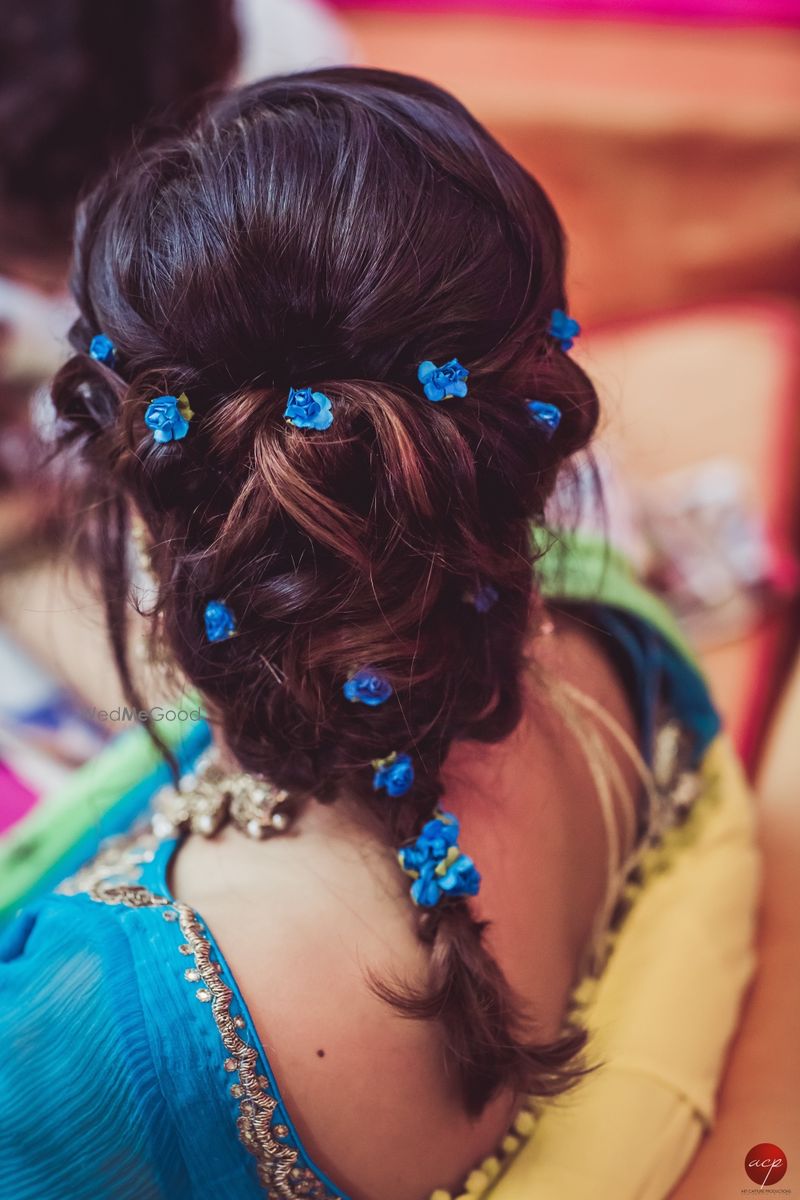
0, 0, 239, 272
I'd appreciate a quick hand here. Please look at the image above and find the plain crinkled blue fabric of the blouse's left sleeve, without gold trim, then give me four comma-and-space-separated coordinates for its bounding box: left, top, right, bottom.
0, 896, 195, 1200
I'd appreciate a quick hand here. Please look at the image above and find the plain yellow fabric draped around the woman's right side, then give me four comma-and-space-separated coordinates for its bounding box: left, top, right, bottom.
489, 738, 759, 1200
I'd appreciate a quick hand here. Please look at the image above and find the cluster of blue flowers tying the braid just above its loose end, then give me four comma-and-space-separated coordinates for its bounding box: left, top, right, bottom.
397, 812, 481, 908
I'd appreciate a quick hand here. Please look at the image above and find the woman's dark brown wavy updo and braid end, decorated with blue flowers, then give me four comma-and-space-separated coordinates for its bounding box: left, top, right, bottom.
54, 68, 597, 1112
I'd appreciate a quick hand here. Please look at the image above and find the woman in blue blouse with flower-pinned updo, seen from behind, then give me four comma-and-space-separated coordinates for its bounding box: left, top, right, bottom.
0, 70, 752, 1200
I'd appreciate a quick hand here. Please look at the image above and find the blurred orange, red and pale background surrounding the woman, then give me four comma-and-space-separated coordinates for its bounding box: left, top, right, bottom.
0, 0, 800, 1198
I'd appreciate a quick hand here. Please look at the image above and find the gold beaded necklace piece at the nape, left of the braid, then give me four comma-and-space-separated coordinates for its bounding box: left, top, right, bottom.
151, 750, 294, 839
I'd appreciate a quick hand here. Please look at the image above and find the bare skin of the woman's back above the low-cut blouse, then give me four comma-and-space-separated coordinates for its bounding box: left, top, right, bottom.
172, 618, 634, 1200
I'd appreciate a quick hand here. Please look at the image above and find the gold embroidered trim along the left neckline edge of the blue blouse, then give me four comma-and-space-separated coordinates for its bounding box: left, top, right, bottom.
58, 833, 335, 1200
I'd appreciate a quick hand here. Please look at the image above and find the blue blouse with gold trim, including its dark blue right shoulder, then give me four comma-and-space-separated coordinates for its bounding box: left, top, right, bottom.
0, 607, 718, 1200
